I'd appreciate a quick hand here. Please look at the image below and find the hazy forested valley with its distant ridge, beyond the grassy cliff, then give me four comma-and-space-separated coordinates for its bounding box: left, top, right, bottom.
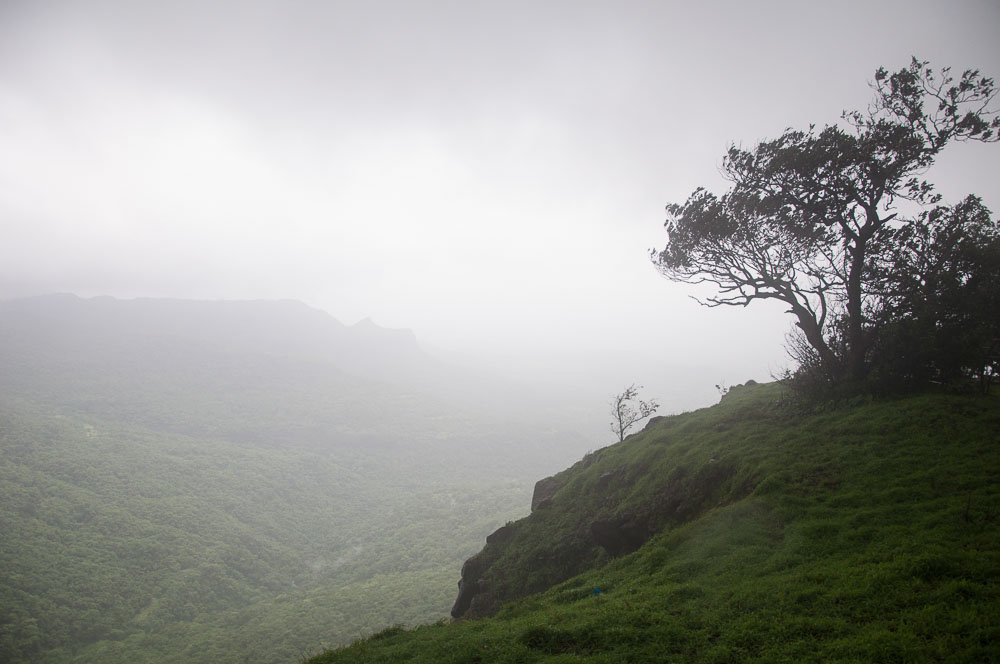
0, 296, 593, 662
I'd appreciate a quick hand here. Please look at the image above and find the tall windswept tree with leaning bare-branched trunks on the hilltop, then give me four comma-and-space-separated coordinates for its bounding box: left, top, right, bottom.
652, 59, 1000, 380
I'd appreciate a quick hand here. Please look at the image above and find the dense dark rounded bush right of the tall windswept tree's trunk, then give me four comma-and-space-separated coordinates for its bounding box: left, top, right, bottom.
872, 196, 1000, 391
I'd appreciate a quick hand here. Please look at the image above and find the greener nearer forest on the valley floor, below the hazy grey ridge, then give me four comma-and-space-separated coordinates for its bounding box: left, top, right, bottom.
0, 394, 530, 662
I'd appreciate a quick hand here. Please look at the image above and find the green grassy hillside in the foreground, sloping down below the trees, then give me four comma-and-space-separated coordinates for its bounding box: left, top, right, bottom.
309, 385, 1000, 664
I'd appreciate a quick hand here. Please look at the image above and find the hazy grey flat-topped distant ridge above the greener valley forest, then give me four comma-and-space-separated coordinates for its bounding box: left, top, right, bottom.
0, 295, 572, 456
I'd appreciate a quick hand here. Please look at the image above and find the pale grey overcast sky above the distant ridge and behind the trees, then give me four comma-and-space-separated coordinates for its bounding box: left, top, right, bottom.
0, 0, 1000, 381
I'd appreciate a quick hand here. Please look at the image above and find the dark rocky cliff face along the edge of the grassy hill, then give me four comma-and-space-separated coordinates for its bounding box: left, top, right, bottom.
451, 418, 753, 618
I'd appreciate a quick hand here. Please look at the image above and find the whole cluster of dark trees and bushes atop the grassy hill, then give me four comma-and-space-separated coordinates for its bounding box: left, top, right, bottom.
653, 58, 1000, 398
